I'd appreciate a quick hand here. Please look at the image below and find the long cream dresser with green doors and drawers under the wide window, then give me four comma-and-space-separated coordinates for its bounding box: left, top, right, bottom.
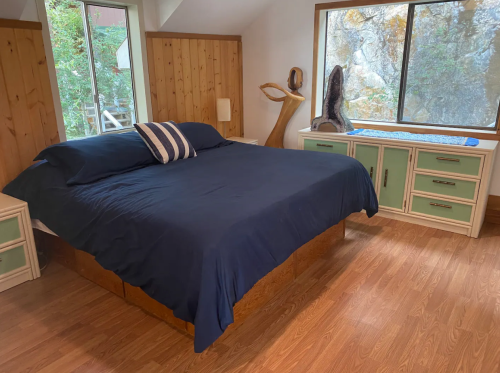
298, 129, 498, 237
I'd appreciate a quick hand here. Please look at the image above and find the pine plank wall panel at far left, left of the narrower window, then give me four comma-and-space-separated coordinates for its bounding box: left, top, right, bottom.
0, 19, 59, 190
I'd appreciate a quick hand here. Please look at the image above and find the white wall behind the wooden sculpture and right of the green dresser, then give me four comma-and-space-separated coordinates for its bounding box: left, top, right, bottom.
243, 0, 500, 195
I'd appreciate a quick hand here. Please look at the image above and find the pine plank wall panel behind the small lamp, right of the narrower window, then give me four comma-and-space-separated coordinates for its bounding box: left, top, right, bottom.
146, 32, 243, 137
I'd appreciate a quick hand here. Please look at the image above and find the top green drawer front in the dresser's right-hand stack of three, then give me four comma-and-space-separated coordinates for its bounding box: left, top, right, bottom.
417, 151, 481, 176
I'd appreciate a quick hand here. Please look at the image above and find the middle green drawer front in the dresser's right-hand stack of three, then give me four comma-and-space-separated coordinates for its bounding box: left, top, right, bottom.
413, 174, 476, 201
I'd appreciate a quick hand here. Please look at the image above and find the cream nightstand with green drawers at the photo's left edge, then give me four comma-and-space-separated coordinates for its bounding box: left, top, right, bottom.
0, 193, 40, 291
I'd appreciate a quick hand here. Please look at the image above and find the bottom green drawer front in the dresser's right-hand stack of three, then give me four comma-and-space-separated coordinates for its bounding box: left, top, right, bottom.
411, 196, 472, 223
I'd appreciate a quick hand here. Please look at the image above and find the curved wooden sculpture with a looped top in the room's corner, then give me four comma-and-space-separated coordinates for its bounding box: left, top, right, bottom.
259, 67, 305, 149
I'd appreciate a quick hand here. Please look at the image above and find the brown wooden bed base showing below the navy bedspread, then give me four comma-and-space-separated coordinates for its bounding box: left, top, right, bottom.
34, 220, 345, 336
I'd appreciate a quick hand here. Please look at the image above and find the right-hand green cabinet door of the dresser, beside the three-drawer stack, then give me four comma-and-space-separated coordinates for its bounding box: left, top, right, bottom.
379, 146, 411, 211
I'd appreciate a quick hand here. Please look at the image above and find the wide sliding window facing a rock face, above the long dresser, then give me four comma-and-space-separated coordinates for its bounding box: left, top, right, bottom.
321, 0, 500, 130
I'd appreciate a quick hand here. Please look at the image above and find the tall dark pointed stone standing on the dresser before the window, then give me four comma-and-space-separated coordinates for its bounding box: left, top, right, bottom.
311, 65, 354, 132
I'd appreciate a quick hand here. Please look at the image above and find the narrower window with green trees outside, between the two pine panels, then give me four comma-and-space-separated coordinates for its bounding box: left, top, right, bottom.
45, 0, 136, 139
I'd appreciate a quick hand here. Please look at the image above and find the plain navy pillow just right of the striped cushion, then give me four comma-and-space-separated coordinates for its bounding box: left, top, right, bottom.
177, 122, 233, 151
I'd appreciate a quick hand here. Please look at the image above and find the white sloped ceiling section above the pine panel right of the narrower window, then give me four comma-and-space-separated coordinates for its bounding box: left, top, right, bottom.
157, 0, 273, 35
